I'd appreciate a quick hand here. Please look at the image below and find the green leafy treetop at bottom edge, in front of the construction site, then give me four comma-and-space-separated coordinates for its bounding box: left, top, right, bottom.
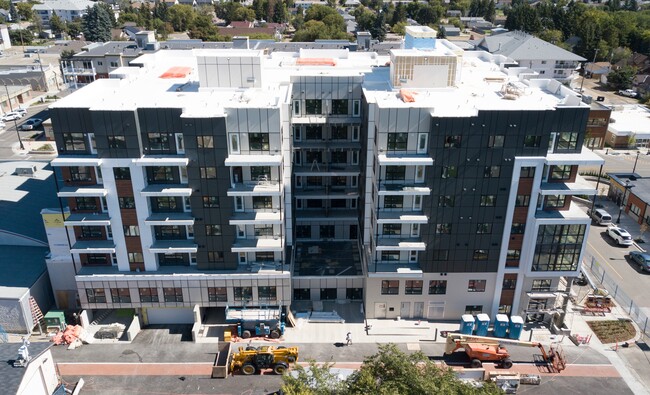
282, 344, 501, 395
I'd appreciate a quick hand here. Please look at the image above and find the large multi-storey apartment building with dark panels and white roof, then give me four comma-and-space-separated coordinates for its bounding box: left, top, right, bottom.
50, 27, 602, 323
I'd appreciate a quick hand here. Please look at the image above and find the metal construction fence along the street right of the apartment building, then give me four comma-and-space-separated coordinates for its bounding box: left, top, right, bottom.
582, 253, 650, 337
